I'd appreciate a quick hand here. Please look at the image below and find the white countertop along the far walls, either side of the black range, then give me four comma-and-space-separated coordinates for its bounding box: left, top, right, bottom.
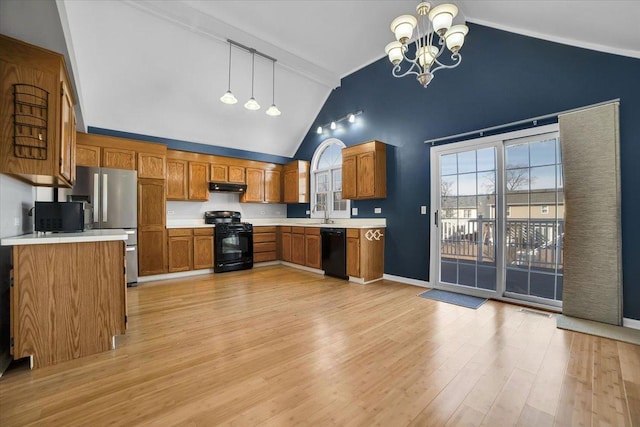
167, 218, 387, 228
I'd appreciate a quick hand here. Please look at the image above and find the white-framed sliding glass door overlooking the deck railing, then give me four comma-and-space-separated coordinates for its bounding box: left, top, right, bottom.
430, 125, 564, 306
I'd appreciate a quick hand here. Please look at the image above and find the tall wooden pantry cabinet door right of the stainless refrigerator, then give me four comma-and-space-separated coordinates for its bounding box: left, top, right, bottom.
138, 179, 167, 276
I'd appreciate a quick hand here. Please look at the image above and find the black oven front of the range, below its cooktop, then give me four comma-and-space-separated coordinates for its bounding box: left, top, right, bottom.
213, 230, 253, 273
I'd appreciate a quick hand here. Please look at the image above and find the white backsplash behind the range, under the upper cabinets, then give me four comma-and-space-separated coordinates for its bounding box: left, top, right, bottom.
167, 193, 287, 221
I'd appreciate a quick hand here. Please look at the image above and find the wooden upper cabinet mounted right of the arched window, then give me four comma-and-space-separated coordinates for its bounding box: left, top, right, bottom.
342, 141, 387, 200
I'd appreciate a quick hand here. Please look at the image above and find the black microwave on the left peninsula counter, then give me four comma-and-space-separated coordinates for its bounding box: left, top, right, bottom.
35, 202, 84, 233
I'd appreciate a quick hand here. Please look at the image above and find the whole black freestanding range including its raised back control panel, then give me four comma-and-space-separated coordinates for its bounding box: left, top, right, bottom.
204, 211, 253, 273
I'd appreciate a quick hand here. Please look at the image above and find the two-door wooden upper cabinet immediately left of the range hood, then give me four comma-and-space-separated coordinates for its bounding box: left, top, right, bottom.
167, 150, 210, 202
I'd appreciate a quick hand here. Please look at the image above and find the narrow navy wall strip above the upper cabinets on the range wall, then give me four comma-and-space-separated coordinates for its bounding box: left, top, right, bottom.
87, 126, 292, 163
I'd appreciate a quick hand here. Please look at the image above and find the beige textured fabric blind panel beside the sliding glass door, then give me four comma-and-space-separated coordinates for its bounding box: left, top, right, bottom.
558, 102, 622, 325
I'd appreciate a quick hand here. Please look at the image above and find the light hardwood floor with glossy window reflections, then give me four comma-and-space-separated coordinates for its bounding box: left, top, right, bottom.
0, 266, 640, 427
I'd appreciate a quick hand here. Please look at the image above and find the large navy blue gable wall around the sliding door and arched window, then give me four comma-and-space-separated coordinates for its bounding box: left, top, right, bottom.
288, 24, 640, 319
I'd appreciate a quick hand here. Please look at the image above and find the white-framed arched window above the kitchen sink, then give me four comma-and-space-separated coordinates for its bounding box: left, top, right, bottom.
311, 138, 351, 218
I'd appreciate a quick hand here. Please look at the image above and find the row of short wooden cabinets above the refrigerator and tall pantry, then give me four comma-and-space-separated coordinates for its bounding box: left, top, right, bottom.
76, 132, 167, 179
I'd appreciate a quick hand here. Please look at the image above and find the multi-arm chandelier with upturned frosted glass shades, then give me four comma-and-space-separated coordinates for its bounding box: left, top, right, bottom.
385, 2, 469, 87
